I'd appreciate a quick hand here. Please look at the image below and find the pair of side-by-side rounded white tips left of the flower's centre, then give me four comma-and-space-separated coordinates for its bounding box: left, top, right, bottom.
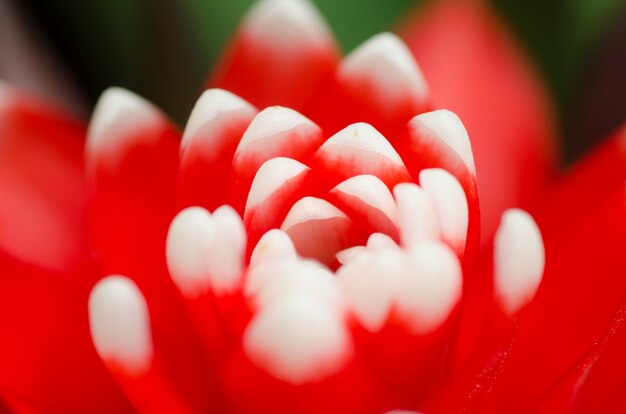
166, 206, 246, 297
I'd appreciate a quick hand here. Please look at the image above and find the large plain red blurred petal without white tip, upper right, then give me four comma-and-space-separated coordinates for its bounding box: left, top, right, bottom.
401, 0, 555, 239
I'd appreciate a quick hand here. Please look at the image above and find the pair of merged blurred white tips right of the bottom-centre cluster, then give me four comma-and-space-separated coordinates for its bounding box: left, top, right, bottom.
337, 239, 463, 335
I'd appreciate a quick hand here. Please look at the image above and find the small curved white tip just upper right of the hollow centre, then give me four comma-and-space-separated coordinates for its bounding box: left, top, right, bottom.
335, 174, 398, 224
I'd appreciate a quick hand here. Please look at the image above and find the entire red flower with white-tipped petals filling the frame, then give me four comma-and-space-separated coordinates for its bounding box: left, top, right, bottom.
0, 0, 626, 413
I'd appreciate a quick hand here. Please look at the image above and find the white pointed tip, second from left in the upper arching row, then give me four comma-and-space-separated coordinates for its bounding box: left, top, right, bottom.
181, 89, 256, 148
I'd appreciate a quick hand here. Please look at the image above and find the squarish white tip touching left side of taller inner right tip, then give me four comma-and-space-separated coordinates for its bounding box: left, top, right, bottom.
393, 183, 440, 247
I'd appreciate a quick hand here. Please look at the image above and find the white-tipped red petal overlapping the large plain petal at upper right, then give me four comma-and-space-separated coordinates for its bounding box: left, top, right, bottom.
304, 33, 429, 137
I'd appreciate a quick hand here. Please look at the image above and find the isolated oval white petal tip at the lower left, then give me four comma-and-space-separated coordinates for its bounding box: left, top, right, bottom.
89, 276, 153, 376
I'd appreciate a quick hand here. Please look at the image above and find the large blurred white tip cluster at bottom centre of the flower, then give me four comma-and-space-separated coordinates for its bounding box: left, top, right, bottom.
243, 230, 352, 384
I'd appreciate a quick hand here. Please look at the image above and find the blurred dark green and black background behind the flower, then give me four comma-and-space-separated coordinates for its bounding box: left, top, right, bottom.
0, 0, 626, 161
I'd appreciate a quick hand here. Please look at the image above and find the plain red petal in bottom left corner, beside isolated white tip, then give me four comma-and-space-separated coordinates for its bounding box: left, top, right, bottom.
0, 253, 132, 413
